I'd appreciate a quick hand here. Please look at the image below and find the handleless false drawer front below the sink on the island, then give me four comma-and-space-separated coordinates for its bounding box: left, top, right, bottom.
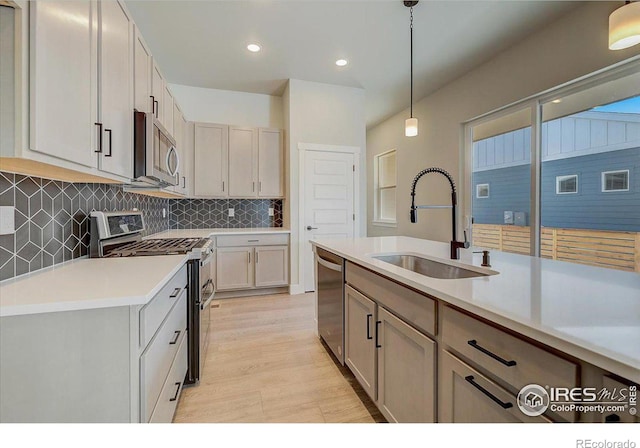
346, 262, 436, 335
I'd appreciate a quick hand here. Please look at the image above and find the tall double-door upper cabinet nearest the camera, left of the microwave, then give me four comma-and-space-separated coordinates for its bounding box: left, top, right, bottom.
30, 1, 133, 178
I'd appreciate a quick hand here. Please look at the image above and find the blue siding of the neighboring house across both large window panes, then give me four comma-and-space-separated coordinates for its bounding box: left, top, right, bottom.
473, 148, 640, 232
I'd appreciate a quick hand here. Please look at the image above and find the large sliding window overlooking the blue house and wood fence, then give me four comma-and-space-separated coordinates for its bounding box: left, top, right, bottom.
464, 61, 640, 271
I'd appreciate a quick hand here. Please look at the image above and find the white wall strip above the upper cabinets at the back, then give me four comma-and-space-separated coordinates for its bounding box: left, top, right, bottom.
169, 84, 284, 129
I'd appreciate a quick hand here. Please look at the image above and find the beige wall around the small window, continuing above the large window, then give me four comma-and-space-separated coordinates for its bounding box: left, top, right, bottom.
367, 2, 640, 241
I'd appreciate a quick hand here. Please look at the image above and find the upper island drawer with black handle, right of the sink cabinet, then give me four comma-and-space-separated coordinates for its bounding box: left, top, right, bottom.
442, 306, 578, 420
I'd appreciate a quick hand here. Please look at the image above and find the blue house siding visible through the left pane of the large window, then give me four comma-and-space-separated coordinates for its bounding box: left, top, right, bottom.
473, 165, 531, 224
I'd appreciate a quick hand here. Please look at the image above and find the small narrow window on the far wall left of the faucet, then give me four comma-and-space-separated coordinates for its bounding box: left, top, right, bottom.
373, 149, 396, 226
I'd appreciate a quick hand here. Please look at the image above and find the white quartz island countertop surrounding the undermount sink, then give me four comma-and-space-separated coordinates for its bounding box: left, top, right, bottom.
312, 237, 640, 382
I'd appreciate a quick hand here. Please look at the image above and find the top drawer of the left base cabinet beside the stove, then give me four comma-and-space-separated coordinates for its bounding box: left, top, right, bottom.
140, 265, 187, 347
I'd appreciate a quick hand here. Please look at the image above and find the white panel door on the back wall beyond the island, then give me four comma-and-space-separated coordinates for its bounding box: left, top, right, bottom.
300, 151, 355, 291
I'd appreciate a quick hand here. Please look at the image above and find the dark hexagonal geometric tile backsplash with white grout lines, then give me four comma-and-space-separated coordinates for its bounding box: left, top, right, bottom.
0, 171, 282, 281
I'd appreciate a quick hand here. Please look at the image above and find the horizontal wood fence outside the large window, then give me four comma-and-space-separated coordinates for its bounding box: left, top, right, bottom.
473, 224, 640, 272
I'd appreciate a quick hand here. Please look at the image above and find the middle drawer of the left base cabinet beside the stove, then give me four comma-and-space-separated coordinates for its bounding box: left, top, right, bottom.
140, 290, 187, 422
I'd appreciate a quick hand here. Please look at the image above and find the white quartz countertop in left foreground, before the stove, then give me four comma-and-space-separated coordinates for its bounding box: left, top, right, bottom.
0, 255, 187, 317
